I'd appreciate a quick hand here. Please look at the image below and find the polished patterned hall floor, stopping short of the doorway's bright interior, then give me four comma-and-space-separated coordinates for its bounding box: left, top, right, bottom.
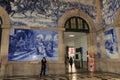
0, 73, 120, 80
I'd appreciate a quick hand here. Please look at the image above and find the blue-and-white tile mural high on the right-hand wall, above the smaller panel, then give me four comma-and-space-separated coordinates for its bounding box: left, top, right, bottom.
100, 0, 120, 26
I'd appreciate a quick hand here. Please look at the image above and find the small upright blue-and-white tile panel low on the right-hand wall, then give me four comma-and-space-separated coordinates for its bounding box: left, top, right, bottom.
104, 29, 119, 59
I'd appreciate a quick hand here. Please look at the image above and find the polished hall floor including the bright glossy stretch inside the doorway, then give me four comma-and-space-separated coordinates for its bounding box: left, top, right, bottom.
0, 63, 120, 80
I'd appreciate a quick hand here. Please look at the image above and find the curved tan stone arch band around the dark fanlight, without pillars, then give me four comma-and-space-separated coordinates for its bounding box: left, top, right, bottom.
58, 9, 96, 32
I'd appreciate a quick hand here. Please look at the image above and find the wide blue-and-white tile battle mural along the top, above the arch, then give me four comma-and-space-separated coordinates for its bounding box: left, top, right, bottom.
0, 0, 96, 27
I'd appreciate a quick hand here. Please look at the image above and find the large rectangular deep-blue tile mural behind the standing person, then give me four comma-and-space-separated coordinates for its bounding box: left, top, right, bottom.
8, 29, 58, 61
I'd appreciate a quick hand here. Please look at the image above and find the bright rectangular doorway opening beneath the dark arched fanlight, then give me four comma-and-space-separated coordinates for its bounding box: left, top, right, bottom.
64, 32, 88, 72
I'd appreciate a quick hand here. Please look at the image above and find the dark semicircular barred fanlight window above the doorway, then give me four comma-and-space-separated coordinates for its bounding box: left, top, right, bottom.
64, 16, 89, 33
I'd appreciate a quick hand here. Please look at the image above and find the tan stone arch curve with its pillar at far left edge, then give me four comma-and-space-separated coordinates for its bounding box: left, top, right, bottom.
0, 7, 10, 76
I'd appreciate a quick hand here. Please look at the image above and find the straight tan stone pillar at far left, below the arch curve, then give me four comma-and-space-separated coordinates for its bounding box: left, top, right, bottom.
1, 28, 10, 76
